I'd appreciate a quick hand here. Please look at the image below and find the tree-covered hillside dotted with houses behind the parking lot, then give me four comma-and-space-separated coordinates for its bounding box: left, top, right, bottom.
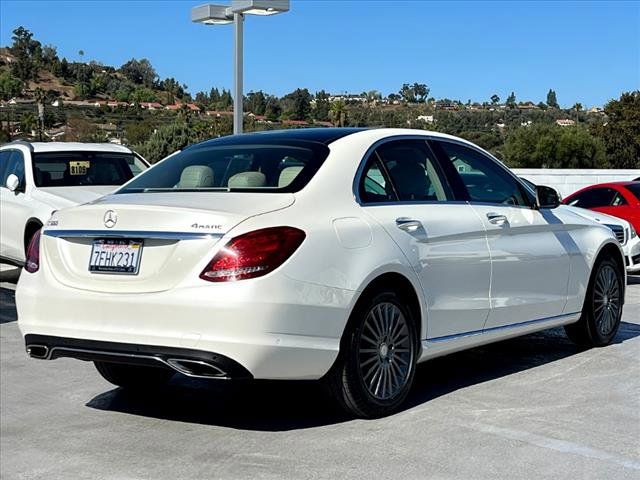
0, 27, 640, 168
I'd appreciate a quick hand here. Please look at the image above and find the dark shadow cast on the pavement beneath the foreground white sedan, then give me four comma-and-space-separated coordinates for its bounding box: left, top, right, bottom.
87, 322, 640, 431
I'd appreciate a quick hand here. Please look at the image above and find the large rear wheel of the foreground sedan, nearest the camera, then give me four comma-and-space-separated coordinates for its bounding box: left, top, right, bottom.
325, 291, 418, 418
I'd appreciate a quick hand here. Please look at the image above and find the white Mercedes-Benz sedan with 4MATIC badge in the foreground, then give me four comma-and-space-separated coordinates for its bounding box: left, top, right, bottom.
16, 129, 626, 417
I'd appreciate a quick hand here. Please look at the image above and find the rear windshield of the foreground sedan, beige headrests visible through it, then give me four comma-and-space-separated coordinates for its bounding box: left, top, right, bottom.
117, 142, 328, 193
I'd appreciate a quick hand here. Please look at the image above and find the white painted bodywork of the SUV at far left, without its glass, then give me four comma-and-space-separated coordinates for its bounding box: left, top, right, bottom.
0, 142, 146, 264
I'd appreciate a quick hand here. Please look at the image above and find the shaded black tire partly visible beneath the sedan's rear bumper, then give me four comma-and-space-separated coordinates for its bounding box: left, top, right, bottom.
93, 362, 175, 390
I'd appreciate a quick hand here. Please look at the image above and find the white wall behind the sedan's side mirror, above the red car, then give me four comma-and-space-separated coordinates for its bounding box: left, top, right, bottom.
511, 168, 640, 198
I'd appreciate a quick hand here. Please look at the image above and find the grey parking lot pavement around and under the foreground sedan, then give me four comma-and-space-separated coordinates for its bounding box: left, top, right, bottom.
0, 266, 640, 480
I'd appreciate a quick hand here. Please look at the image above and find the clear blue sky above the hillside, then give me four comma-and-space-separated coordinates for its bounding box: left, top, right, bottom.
0, 0, 640, 106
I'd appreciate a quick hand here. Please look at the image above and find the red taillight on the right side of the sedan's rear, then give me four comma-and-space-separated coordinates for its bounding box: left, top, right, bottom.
200, 227, 305, 282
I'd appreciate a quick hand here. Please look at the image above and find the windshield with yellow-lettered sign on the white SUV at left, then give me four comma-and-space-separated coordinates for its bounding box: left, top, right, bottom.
33, 152, 147, 187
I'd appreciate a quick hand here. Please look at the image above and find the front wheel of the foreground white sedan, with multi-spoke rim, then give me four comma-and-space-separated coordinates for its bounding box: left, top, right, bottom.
564, 258, 624, 347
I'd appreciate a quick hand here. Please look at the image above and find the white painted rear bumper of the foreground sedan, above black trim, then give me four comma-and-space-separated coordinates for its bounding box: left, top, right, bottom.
16, 269, 355, 379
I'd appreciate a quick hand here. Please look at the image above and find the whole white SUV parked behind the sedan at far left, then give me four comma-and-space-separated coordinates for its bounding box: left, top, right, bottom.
0, 141, 149, 265
